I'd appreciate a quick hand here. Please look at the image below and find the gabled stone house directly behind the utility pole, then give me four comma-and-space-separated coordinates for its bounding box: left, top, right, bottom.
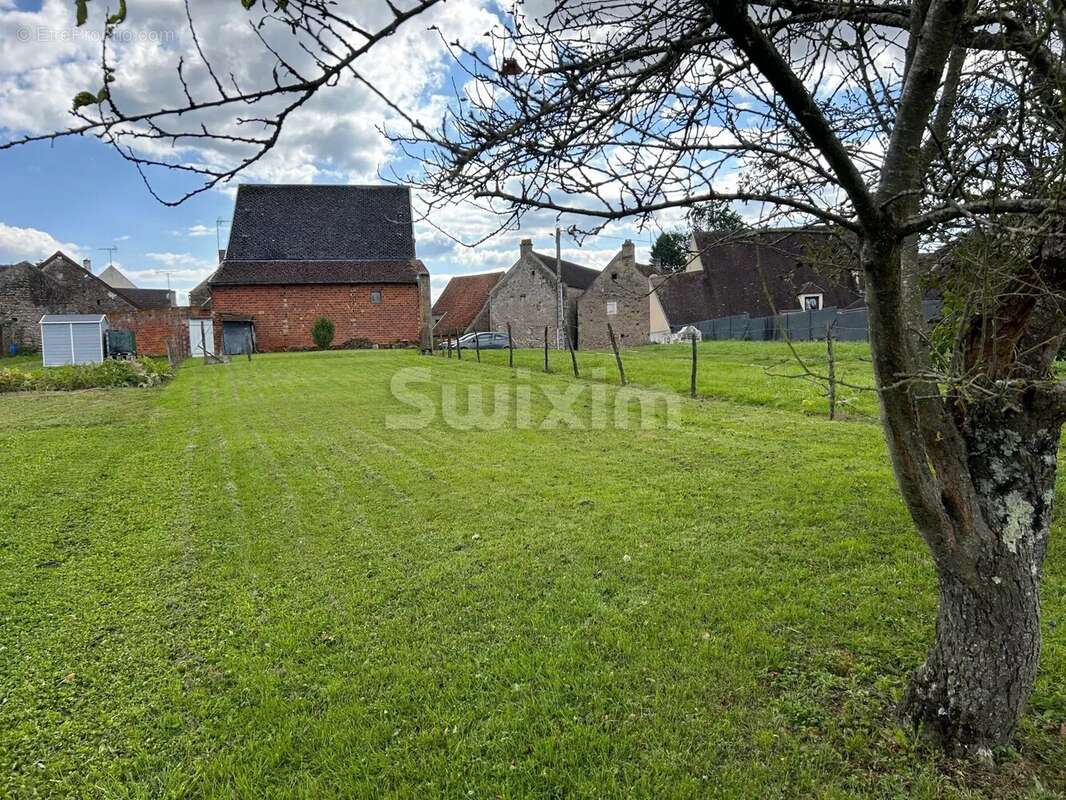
488, 239, 599, 348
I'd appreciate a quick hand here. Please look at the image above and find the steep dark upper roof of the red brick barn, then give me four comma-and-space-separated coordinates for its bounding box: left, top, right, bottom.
226, 183, 415, 261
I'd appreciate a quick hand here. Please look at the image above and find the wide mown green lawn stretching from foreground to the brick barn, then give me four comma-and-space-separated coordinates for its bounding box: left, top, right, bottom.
0, 343, 1066, 798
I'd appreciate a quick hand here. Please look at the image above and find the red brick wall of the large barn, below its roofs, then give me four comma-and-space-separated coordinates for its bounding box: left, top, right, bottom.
211, 284, 421, 351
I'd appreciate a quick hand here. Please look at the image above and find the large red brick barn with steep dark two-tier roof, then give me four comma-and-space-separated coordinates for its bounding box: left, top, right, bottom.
208, 185, 431, 352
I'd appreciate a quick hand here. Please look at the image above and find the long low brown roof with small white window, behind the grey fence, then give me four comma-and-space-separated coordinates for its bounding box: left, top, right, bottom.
660, 229, 860, 325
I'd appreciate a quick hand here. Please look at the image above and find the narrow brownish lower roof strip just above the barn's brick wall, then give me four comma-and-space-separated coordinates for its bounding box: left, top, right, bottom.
208, 258, 427, 287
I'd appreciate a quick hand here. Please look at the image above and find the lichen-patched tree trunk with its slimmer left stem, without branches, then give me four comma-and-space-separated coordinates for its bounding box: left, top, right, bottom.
865, 243, 1060, 764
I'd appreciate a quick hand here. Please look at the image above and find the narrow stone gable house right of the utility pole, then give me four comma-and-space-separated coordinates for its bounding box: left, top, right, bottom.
578, 239, 656, 350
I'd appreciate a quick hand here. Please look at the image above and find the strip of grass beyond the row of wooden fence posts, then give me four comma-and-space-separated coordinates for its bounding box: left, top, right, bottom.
464, 341, 877, 420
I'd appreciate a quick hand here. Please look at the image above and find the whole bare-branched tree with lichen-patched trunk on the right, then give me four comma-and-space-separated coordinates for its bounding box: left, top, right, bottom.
0, 0, 1066, 761
